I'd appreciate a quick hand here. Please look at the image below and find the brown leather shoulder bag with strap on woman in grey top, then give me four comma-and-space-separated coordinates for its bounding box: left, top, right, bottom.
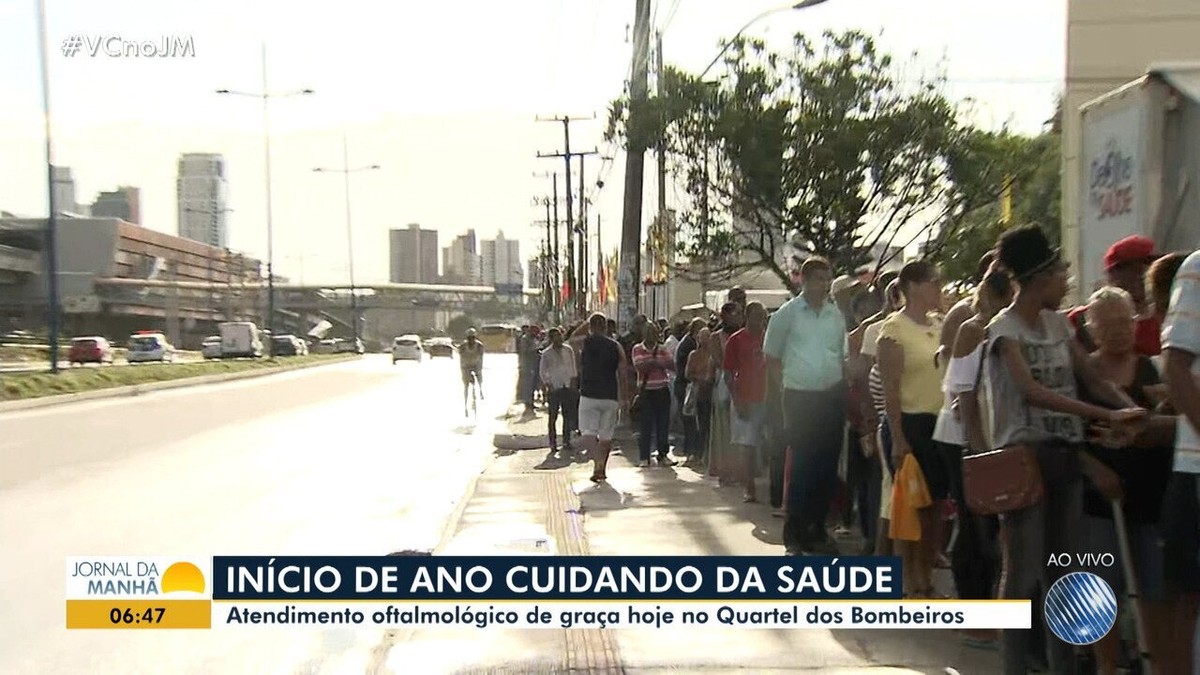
962, 329, 1045, 515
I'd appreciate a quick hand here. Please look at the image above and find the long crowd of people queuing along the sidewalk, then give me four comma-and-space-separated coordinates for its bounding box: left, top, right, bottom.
523, 226, 1200, 674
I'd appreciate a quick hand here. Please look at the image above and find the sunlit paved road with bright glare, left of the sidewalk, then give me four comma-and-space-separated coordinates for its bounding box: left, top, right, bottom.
0, 356, 516, 674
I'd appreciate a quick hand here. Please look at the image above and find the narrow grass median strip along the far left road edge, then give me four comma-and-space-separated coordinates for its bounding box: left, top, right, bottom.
0, 354, 346, 401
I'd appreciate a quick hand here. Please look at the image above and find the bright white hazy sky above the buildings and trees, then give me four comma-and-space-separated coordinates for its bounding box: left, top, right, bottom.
0, 0, 1066, 282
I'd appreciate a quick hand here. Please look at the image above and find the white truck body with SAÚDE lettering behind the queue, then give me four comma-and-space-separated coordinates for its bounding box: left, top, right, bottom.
1068, 62, 1200, 298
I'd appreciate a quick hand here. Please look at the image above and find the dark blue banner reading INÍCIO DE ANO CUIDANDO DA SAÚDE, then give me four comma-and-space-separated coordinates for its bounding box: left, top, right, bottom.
212, 556, 902, 602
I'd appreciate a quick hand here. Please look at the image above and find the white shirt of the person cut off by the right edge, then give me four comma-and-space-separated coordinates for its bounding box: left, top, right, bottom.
1163, 251, 1200, 473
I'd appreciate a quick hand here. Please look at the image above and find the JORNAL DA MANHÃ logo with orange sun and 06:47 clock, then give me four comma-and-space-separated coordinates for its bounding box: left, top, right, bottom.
66, 556, 212, 629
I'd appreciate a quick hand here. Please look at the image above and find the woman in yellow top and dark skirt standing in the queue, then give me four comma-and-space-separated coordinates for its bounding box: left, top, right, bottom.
877, 261, 949, 598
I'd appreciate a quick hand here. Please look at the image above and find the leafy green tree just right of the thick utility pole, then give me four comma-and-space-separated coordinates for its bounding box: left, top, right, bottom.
608, 31, 998, 292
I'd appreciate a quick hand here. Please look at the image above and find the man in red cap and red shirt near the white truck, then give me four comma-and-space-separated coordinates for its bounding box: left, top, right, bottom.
1067, 234, 1163, 357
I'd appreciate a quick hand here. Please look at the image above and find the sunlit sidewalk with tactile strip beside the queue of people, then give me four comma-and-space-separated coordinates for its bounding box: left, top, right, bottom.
384, 408, 1000, 675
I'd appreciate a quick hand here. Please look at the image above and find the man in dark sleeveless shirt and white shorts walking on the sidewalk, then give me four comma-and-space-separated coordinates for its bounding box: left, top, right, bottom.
580, 312, 629, 483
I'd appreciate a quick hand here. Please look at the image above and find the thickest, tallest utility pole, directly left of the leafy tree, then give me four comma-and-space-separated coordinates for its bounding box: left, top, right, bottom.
617, 0, 650, 328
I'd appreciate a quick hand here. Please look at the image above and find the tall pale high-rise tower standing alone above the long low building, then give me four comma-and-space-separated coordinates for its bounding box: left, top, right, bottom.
175, 153, 229, 249
